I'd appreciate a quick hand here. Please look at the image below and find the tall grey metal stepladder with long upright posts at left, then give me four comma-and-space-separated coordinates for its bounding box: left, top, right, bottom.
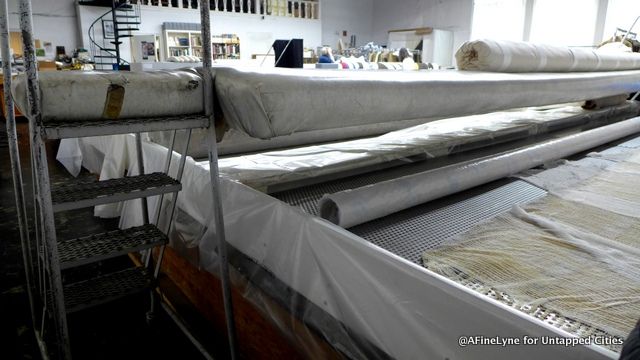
5, 0, 235, 359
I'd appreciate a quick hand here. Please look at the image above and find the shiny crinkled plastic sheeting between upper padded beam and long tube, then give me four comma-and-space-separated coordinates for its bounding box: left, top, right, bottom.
220, 102, 638, 190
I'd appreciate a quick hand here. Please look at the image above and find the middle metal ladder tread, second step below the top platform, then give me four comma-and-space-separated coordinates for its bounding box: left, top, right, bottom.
58, 224, 169, 270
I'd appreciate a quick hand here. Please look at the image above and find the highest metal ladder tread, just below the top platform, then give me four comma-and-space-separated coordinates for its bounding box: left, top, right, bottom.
51, 173, 182, 212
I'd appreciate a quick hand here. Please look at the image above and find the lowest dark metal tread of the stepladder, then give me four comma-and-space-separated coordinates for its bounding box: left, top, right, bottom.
64, 267, 153, 313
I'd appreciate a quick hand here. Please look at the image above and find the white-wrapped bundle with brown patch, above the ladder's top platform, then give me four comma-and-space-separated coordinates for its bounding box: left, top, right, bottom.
12, 69, 204, 122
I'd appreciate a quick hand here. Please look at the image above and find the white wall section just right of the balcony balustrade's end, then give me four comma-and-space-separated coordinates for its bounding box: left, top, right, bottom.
320, 0, 373, 49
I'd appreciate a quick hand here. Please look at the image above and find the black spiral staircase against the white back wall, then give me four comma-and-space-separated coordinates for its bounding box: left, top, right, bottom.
89, 0, 141, 70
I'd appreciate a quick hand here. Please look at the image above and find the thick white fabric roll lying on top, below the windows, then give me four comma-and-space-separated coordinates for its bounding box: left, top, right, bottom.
456, 39, 640, 72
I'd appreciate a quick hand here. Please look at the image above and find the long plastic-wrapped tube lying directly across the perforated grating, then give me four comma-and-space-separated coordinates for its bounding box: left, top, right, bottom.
318, 117, 640, 228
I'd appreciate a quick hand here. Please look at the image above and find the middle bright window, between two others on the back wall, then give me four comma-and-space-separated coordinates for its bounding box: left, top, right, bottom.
530, 0, 596, 46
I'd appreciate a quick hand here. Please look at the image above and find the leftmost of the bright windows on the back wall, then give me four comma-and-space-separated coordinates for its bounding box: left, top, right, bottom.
471, 0, 525, 40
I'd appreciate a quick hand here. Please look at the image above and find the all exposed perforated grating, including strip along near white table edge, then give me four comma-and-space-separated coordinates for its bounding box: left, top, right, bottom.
274, 161, 622, 352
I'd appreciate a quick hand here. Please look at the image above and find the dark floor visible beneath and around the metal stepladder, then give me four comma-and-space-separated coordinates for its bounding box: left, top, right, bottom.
0, 119, 202, 359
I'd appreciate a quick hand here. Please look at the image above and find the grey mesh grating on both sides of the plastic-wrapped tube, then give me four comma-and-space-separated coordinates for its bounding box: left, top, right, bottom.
273, 173, 546, 263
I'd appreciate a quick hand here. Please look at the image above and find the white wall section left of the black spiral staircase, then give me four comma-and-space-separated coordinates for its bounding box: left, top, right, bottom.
9, 0, 80, 54
